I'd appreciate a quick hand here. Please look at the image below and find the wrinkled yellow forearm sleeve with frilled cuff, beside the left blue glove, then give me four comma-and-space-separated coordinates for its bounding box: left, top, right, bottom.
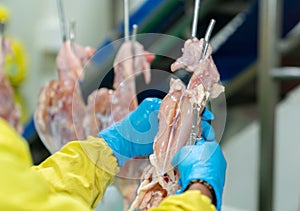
33, 137, 119, 207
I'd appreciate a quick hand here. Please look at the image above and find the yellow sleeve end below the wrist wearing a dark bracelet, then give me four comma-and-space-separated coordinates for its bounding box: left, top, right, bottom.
149, 190, 216, 211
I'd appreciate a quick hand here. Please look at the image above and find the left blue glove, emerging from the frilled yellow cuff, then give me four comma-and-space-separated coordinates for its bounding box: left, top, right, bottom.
98, 98, 161, 166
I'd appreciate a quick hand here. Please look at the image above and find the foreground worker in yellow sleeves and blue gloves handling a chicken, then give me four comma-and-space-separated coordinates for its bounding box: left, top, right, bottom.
0, 98, 226, 211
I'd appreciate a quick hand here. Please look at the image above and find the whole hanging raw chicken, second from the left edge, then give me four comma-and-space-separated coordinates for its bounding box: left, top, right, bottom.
34, 41, 95, 153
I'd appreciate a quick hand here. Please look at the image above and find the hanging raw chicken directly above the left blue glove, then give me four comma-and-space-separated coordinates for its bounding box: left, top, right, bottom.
84, 41, 154, 135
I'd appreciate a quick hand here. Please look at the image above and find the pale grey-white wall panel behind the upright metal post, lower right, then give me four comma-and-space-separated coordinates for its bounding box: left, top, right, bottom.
223, 86, 300, 211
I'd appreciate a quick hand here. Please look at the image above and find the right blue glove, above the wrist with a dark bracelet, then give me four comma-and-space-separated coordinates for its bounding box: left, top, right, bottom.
172, 109, 226, 210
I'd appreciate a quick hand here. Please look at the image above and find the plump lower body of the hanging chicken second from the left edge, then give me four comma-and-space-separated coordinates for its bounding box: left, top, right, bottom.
34, 80, 86, 153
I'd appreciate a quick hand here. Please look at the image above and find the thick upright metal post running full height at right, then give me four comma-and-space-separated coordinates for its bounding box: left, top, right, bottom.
258, 0, 281, 211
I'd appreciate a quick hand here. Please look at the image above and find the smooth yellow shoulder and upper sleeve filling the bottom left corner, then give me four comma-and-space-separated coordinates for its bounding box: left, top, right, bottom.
0, 118, 92, 211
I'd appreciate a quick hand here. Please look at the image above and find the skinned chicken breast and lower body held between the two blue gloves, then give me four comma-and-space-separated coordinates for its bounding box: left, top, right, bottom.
130, 79, 205, 210
